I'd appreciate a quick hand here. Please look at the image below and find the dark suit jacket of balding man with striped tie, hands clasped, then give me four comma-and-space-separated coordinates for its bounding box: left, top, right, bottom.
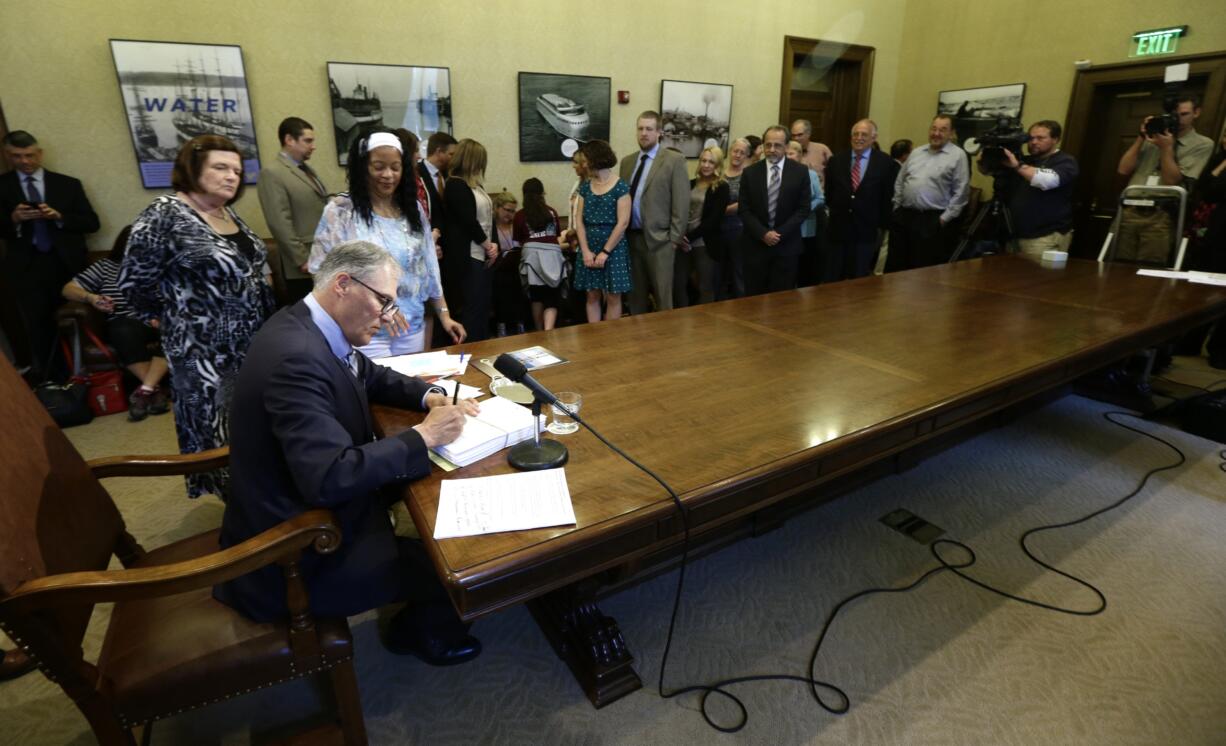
737, 158, 809, 256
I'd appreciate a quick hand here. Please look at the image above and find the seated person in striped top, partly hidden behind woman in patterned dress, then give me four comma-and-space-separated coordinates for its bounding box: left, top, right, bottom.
61, 220, 170, 422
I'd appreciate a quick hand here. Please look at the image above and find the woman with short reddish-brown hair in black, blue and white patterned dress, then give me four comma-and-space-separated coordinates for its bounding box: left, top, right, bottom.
119, 135, 273, 499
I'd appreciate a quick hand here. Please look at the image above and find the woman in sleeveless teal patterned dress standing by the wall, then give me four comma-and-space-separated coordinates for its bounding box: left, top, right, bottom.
575, 140, 630, 321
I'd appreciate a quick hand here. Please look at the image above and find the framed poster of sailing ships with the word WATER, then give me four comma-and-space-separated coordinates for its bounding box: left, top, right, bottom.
110, 39, 260, 189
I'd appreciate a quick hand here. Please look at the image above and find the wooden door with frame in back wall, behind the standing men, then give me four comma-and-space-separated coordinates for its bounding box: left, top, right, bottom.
779, 37, 874, 150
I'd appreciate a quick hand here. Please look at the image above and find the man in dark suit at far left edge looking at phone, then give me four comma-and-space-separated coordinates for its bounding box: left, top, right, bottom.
0, 130, 98, 379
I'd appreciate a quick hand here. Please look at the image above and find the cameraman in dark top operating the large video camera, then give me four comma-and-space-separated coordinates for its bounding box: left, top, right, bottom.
977, 119, 1079, 256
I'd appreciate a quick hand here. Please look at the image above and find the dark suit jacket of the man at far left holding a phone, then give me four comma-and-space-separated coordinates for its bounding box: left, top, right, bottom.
0, 169, 98, 272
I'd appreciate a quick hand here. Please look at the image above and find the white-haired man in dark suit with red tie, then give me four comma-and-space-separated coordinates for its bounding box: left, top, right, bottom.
821, 119, 897, 282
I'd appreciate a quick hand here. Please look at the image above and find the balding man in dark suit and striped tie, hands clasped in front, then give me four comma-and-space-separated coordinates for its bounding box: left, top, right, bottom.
737, 125, 809, 296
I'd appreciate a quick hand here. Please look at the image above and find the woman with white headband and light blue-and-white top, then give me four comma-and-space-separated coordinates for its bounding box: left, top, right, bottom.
307, 130, 465, 357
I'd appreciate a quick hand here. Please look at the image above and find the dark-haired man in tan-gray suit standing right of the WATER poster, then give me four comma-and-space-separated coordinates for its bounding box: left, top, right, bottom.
256, 117, 327, 303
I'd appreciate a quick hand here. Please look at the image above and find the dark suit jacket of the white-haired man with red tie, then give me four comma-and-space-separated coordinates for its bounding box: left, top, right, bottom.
826, 148, 899, 243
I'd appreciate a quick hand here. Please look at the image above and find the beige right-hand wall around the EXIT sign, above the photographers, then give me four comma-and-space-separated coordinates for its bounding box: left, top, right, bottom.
888, 0, 1226, 192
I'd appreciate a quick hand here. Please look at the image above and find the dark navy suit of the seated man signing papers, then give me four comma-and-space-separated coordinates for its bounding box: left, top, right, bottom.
215, 302, 430, 621
